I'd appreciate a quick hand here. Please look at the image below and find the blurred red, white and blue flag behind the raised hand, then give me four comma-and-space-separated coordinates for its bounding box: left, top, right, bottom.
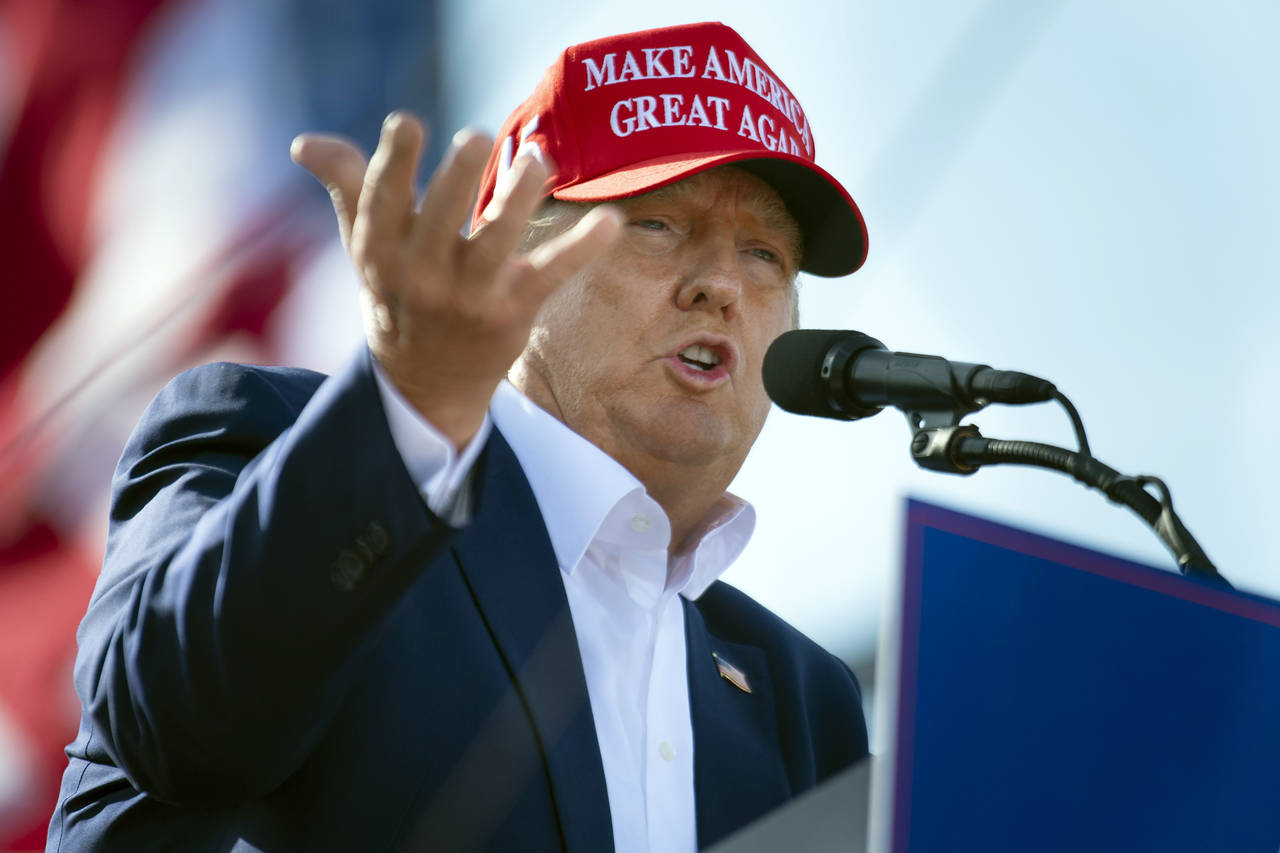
0, 0, 447, 835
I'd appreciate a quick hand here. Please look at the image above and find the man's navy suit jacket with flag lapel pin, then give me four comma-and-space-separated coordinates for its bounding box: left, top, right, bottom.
49, 353, 867, 853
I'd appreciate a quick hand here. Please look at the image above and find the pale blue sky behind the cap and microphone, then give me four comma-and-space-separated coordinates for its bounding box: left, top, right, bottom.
440, 0, 1280, 660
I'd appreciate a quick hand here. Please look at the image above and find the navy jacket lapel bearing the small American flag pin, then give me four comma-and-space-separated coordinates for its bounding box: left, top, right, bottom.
684, 601, 791, 848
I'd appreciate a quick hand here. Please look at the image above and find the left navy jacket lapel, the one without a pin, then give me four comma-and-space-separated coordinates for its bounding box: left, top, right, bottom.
454, 430, 613, 853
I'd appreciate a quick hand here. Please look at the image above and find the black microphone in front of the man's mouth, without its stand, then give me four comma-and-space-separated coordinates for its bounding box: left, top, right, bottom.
764, 329, 1057, 420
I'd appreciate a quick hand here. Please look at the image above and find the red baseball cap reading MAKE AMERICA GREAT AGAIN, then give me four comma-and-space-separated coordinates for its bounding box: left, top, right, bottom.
471, 23, 867, 275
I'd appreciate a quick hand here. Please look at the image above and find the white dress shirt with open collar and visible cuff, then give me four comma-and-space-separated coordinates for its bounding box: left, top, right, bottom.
375, 370, 755, 853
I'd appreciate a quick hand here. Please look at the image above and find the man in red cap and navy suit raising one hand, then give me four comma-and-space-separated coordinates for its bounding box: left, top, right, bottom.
50, 24, 867, 852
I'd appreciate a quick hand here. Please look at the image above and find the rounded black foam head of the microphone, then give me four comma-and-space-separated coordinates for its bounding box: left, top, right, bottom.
763, 329, 884, 420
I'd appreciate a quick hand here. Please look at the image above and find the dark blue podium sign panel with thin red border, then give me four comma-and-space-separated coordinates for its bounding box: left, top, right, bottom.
890, 501, 1280, 853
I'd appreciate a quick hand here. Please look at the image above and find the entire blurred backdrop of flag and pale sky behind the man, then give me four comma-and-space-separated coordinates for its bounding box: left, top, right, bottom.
0, 0, 1280, 850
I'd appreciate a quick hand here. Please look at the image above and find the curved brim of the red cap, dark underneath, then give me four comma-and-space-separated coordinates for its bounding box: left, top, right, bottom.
552, 149, 867, 277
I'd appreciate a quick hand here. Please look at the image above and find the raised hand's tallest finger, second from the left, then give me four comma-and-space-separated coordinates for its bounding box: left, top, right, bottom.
352, 113, 425, 275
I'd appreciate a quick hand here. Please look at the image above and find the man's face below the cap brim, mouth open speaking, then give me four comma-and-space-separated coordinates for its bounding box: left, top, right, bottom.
515, 168, 800, 484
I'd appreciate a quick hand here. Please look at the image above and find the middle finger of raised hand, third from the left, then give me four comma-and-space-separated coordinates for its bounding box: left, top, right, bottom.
413, 129, 493, 252
